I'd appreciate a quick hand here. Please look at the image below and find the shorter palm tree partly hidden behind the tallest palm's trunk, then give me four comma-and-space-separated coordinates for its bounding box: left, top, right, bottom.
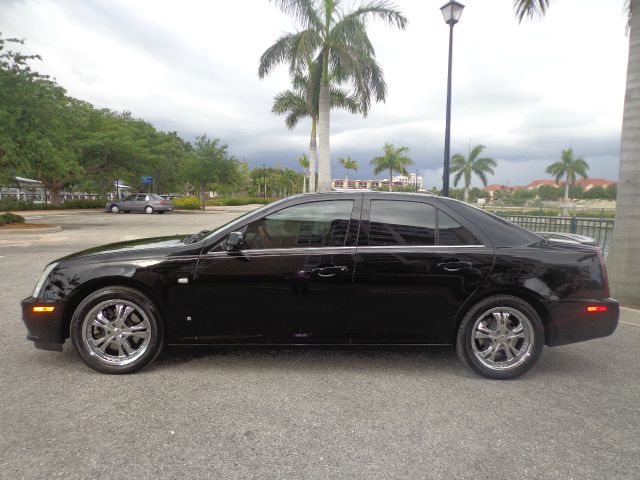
271, 63, 362, 192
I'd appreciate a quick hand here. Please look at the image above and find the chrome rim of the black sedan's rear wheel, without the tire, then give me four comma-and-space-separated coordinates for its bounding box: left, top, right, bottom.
471, 307, 535, 371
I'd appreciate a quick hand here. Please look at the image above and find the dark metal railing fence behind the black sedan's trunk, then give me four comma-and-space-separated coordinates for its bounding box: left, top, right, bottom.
500, 214, 614, 258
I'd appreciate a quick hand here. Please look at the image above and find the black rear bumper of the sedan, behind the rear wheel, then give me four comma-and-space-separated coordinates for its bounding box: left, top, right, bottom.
546, 298, 620, 347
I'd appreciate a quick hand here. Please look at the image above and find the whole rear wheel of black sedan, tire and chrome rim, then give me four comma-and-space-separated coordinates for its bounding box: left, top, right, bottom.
456, 295, 544, 380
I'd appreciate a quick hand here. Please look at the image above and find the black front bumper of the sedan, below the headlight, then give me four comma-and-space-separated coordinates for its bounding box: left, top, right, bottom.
20, 297, 67, 351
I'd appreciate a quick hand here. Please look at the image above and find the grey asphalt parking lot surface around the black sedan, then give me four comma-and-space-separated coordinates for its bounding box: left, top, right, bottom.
0, 207, 640, 479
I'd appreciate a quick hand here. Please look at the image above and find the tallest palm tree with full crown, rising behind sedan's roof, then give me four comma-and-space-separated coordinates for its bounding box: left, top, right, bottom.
258, 0, 407, 192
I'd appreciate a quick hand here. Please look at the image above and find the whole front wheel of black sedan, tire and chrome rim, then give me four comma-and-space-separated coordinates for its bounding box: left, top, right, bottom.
70, 286, 164, 374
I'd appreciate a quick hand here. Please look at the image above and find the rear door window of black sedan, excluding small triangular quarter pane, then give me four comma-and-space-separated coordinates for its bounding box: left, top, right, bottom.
369, 200, 436, 247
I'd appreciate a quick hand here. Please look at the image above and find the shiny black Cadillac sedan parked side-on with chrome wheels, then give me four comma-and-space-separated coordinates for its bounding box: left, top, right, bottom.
22, 192, 619, 379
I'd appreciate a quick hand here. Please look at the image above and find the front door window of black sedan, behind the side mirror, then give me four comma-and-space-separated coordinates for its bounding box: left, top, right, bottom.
244, 200, 353, 250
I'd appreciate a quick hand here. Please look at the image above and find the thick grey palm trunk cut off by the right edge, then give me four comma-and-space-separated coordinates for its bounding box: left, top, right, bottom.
607, 0, 640, 305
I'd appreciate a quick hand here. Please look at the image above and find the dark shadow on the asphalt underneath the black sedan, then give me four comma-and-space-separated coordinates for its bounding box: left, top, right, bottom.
46, 341, 610, 381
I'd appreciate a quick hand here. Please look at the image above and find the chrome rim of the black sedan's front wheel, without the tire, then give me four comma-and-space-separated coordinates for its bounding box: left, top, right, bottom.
82, 299, 151, 365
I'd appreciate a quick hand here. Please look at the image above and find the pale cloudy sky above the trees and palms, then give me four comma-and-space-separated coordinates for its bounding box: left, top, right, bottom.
0, 0, 628, 186
